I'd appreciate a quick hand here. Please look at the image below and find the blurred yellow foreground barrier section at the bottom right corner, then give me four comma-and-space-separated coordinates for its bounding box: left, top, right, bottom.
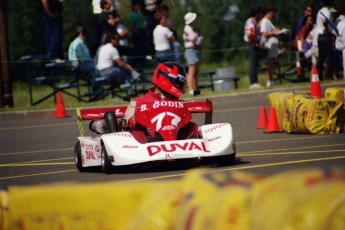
250, 169, 345, 230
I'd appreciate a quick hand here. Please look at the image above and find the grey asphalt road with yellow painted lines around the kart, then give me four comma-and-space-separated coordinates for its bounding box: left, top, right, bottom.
0, 86, 345, 189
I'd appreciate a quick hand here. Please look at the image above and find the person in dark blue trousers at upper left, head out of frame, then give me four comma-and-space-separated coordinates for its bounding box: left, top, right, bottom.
41, 0, 64, 59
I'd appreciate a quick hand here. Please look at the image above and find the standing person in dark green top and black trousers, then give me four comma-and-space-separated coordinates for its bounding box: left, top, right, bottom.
129, 0, 146, 66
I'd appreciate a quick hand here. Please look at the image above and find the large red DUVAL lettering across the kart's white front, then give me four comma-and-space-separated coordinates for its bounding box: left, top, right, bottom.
146, 141, 210, 156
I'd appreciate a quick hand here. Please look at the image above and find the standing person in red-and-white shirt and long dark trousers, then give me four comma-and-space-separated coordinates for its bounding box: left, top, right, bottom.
244, 6, 263, 89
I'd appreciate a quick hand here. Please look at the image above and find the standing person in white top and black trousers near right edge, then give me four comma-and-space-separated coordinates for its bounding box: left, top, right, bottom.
316, 0, 334, 80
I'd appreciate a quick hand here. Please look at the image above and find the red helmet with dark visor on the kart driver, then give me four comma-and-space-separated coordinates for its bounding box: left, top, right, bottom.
152, 62, 186, 98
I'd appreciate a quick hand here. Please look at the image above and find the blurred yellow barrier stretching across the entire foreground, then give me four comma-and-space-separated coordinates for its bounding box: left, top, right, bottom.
0, 168, 345, 230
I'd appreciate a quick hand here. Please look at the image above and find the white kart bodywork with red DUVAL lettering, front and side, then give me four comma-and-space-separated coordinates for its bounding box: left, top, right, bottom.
78, 123, 236, 167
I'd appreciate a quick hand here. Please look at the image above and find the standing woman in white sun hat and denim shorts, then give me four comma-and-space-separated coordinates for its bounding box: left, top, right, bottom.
183, 12, 203, 95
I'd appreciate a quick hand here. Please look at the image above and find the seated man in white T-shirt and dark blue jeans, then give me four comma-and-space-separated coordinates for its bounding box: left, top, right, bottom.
97, 32, 135, 90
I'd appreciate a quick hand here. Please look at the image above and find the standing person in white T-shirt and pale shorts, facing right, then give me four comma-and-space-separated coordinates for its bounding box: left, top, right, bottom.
260, 5, 280, 87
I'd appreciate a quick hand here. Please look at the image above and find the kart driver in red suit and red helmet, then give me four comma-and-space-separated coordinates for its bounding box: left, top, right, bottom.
124, 62, 199, 143
